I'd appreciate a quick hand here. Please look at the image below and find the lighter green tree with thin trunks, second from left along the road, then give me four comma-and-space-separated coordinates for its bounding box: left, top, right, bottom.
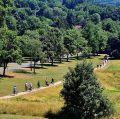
22, 30, 42, 73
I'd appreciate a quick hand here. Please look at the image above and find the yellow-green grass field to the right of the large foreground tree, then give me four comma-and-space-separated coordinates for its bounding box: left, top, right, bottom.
95, 60, 120, 119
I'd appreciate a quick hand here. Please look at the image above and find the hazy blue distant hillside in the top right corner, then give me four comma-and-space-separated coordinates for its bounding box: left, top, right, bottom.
89, 0, 120, 6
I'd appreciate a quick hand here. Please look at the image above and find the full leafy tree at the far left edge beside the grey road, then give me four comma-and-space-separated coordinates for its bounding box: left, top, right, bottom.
0, 28, 23, 75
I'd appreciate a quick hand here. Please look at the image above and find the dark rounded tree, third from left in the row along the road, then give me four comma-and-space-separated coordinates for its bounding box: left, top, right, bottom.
41, 28, 64, 65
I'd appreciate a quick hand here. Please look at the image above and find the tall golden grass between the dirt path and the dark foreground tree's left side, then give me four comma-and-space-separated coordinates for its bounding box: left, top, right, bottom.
0, 84, 64, 117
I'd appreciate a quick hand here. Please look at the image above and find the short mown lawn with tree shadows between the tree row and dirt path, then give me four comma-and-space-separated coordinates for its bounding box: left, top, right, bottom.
0, 56, 103, 97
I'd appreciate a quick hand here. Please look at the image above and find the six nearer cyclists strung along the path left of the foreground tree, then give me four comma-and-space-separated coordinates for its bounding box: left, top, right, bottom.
13, 78, 54, 94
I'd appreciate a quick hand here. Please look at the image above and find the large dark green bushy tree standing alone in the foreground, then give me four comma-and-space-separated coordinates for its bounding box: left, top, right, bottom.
61, 61, 114, 119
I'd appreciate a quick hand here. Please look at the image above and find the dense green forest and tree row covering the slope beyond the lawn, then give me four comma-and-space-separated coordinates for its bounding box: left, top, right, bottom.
0, 0, 120, 74
